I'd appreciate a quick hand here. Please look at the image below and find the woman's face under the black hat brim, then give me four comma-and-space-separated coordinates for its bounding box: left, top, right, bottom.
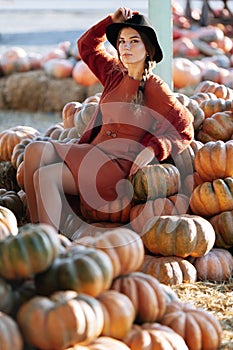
118, 27, 147, 66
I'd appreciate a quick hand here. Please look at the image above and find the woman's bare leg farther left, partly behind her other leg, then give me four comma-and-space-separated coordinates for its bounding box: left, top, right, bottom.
24, 141, 61, 223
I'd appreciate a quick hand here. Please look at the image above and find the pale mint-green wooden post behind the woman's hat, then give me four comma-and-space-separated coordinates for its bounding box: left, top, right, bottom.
148, 0, 173, 89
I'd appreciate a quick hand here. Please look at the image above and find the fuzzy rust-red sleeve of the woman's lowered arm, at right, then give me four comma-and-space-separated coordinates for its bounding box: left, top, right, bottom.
142, 79, 194, 161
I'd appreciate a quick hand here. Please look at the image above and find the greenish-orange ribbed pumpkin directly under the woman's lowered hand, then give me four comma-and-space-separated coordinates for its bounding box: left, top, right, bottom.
128, 163, 180, 202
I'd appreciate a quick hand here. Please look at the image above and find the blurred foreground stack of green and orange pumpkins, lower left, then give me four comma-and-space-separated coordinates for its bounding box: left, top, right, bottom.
0, 207, 222, 350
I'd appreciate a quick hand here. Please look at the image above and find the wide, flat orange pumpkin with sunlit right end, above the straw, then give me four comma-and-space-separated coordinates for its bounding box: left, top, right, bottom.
142, 214, 215, 258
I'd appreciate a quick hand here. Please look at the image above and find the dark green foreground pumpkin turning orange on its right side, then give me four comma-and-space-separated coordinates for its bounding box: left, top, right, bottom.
35, 244, 113, 296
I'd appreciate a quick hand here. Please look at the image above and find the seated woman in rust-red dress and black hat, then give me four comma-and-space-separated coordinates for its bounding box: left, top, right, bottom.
25, 7, 194, 234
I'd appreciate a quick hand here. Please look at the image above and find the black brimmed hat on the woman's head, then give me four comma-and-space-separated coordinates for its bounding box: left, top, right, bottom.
106, 14, 163, 63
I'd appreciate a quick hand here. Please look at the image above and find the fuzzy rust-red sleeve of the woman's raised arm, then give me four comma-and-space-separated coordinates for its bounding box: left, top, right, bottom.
77, 15, 117, 86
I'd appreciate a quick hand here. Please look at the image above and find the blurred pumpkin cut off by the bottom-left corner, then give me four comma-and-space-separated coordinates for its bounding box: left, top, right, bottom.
0, 312, 23, 350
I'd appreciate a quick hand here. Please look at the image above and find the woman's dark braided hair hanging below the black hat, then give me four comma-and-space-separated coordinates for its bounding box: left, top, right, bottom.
117, 30, 156, 105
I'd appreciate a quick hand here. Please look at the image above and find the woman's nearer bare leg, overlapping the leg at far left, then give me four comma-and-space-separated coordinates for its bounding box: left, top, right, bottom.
33, 163, 78, 230
